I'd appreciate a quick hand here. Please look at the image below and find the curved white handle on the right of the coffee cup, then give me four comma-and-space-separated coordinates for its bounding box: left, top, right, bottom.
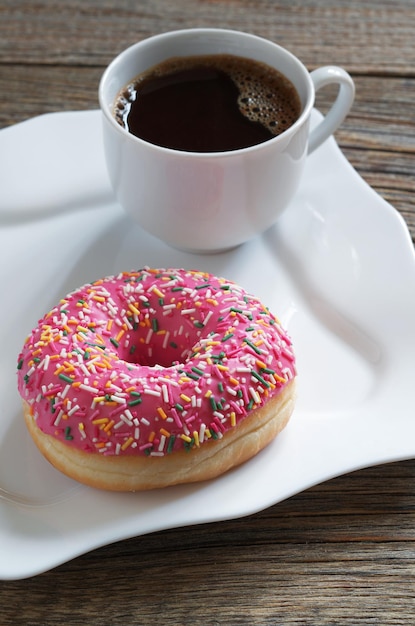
308, 65, 355, 154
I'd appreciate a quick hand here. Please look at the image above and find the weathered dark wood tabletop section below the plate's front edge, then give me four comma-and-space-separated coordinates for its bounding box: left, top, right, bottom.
0, 461, 415, 626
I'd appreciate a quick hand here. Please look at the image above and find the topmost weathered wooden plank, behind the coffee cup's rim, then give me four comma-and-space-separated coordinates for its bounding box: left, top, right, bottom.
0, 0, 415, 76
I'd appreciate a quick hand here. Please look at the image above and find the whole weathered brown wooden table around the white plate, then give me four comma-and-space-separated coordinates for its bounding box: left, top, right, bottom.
0, 0, 415, 626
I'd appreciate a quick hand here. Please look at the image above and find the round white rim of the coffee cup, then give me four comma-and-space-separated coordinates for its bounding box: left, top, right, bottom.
98, 28, 315, 158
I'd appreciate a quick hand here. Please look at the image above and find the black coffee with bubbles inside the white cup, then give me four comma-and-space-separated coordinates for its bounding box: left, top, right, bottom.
114, 55, 301, 152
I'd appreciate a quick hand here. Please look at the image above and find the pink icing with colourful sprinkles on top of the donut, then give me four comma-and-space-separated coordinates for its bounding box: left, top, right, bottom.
18, 268, 296, 456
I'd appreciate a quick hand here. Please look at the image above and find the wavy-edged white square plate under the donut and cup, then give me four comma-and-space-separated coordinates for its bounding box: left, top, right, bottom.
0, 111, 415, 579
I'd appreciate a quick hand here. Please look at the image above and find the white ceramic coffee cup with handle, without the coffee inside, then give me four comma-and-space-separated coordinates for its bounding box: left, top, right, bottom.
99, 28, 354, 252
